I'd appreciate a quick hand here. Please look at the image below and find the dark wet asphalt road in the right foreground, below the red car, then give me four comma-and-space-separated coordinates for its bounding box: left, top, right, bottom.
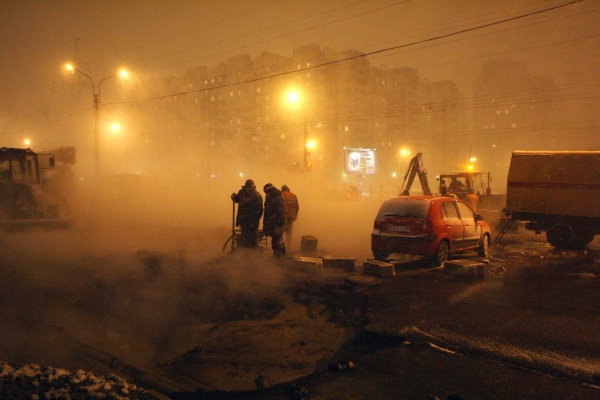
198, 231, 600, 400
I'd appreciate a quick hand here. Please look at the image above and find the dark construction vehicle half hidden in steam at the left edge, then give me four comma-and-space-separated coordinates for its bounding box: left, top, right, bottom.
0, 147, 71, 229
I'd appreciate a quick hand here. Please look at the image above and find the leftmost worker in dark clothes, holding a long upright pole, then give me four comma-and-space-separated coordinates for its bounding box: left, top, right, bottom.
231, 179, 263, 248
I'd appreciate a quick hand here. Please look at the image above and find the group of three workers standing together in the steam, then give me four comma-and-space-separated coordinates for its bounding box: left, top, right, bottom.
231, 179, 300, 256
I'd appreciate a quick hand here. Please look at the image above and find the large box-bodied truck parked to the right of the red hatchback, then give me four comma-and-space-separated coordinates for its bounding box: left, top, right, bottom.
505, 151, 600, 249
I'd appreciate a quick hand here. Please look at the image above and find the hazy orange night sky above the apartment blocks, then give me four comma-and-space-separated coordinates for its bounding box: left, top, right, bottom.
0, 0, 600, 152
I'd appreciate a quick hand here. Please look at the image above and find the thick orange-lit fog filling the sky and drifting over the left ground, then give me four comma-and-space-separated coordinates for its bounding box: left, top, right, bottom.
0, 0, 600, 382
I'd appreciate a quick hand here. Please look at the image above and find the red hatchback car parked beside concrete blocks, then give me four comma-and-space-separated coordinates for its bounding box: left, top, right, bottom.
371, 196, 491, 266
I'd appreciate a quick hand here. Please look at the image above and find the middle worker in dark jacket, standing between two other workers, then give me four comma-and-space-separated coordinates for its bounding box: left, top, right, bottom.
263, 183, 286, 256
